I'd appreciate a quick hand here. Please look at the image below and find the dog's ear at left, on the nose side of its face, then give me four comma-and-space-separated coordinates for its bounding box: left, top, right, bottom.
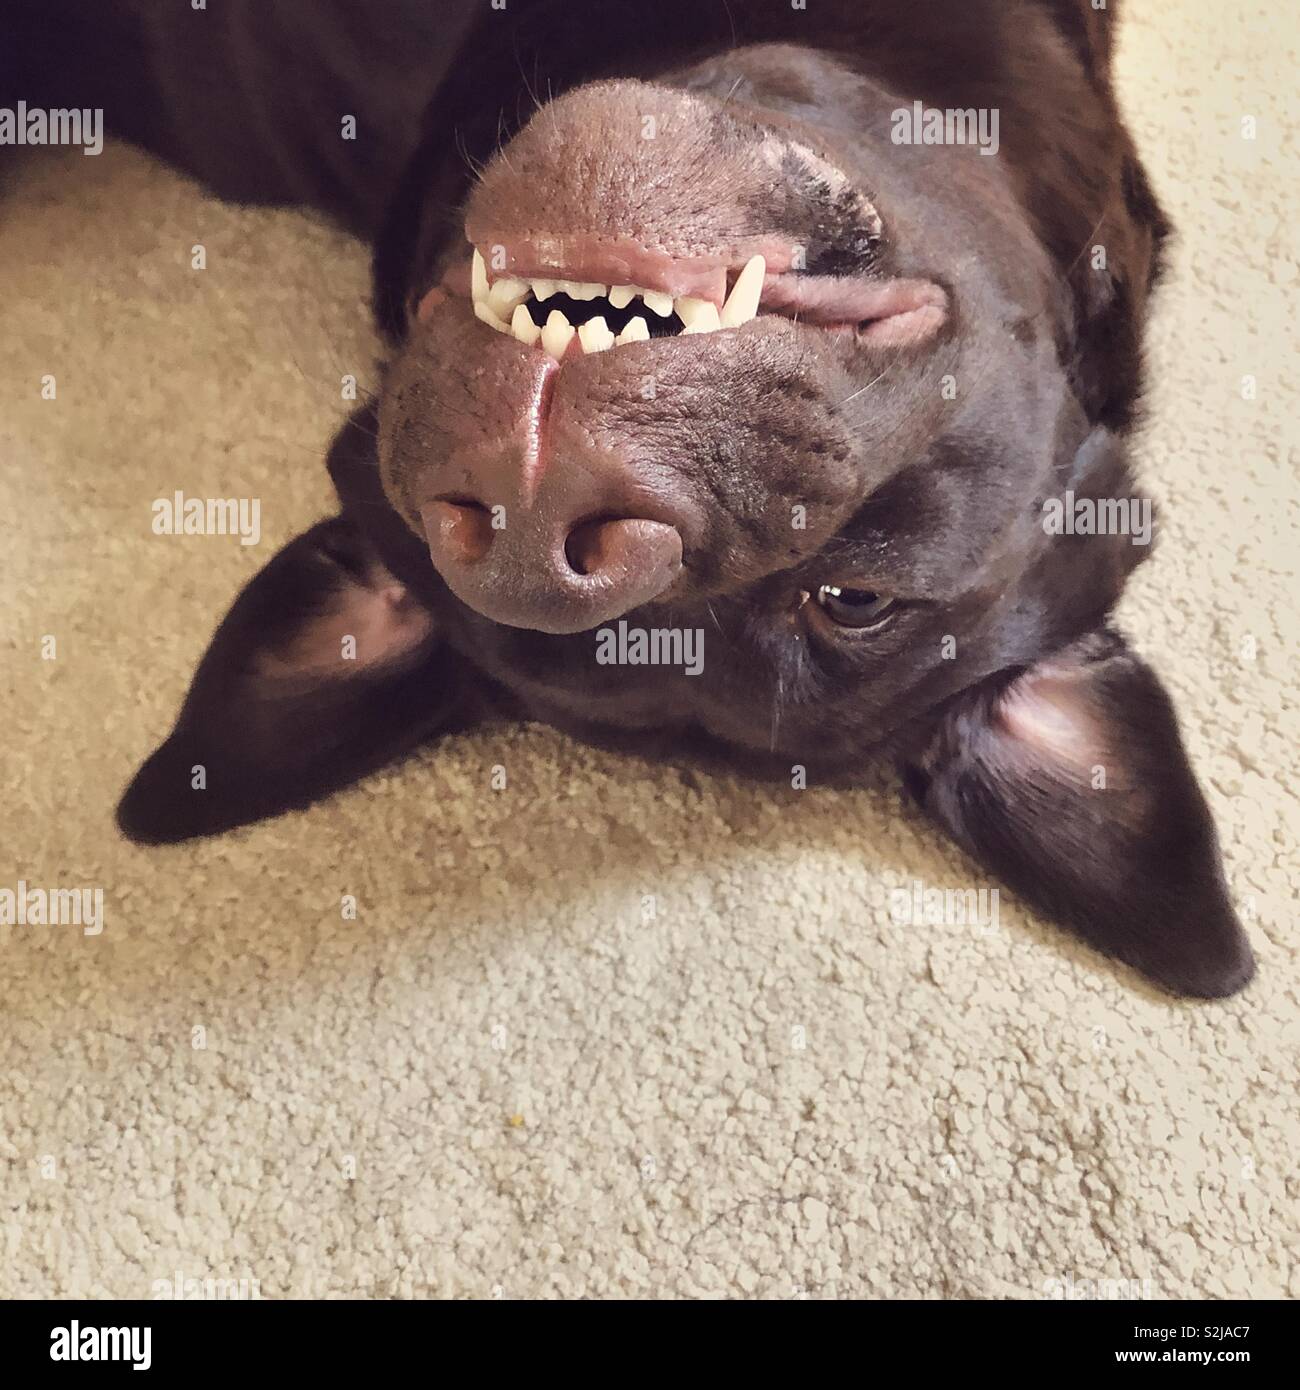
117, 516, 474, 844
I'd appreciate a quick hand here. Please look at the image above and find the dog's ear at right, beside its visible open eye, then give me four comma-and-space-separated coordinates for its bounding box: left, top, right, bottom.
902, 630, 1254, 998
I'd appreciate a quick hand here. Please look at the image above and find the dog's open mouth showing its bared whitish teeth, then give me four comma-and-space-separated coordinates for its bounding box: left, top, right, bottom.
470, 250, 767, 361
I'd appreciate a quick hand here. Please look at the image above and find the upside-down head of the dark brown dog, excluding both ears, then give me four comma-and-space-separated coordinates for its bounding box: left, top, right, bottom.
380, 46, 1150, 759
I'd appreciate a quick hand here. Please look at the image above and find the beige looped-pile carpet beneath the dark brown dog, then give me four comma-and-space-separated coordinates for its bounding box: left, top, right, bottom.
0, 0, 1300, 1298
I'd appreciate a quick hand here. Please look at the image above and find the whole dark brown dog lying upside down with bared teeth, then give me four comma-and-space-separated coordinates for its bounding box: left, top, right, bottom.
7, 0, 1253, 995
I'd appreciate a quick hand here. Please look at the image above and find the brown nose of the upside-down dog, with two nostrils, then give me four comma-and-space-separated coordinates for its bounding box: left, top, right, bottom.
420, 498, 683, 632
